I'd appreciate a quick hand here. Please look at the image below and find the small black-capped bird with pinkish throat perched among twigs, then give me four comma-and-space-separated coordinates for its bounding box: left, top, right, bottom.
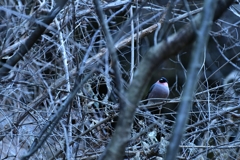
147, 77, 169, 104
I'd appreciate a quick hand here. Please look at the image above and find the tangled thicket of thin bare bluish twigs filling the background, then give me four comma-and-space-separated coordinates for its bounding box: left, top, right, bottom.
0, 0, 240, 160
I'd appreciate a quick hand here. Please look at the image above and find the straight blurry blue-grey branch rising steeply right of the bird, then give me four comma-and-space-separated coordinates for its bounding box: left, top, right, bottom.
166, 0, 217, 160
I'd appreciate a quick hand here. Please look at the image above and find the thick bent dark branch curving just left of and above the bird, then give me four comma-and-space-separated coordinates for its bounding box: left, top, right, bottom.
101, 0, 233, 160
